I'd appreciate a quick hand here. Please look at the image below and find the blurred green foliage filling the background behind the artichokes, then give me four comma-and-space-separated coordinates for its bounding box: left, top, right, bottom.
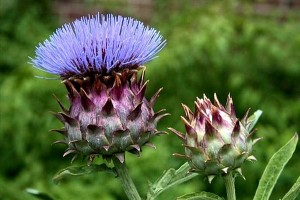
0, 0, 300, 200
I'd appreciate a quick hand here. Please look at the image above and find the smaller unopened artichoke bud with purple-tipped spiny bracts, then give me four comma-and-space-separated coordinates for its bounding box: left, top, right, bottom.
170, 94, 258, 182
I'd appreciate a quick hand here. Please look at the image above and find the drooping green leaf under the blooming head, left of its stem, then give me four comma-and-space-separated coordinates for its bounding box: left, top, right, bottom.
53, 164, 117, 184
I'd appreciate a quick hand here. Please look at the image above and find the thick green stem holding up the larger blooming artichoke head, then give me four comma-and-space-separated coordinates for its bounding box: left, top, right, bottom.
113, 158, 141, 200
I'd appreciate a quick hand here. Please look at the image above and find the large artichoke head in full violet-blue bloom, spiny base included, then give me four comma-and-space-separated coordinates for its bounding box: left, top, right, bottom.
32, 14, 168, 163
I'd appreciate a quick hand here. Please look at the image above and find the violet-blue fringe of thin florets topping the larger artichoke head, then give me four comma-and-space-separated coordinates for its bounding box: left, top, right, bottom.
31, 13, 166, 78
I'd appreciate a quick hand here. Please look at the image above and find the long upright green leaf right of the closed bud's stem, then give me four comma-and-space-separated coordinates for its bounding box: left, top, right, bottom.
253, 134, 298, 200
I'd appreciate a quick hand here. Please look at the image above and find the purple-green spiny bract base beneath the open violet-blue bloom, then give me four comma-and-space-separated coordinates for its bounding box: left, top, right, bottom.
54, 69, 168, 162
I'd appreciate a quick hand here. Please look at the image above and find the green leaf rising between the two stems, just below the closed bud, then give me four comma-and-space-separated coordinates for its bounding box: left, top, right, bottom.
147, 162, 198, 200
